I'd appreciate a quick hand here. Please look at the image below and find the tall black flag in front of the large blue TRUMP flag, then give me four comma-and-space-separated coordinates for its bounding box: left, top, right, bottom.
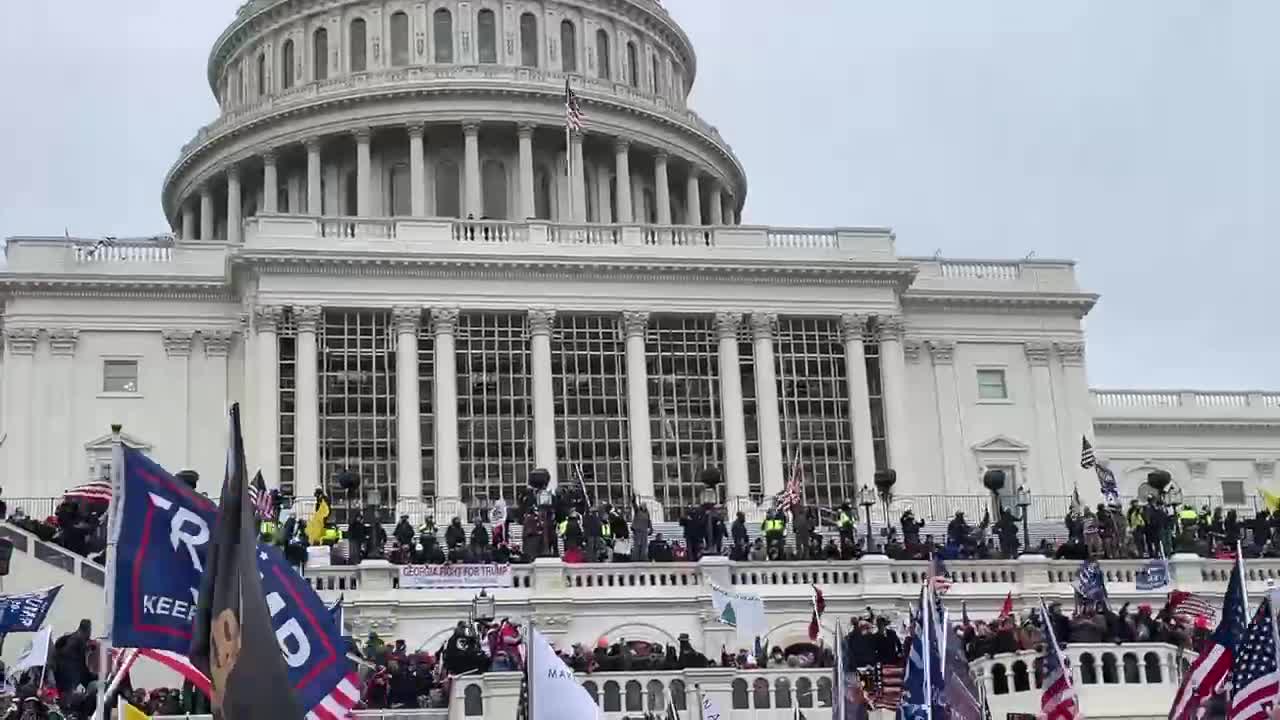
188, 404, 303, 720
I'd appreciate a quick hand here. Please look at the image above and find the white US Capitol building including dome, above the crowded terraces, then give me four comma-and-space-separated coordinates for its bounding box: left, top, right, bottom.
0, 0, 1280, 519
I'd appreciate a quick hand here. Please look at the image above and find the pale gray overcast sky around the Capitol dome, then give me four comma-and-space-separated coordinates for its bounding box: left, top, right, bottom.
0, 0, 1280, 389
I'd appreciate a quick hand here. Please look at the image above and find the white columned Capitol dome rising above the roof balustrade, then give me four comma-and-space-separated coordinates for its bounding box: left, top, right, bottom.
164, 0, 746, 237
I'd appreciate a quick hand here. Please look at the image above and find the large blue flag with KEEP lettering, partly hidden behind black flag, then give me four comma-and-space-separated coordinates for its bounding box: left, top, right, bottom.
111, 447, 360, 710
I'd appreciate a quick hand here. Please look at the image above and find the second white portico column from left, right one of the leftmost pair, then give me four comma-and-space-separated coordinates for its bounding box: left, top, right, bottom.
293, 306, 324, 498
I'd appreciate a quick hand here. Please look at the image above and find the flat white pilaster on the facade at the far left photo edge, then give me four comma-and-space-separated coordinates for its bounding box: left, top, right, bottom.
4, 328, 36, 497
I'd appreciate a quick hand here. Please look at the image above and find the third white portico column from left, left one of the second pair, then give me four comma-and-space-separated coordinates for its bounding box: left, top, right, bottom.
392, 306, 422, 500
